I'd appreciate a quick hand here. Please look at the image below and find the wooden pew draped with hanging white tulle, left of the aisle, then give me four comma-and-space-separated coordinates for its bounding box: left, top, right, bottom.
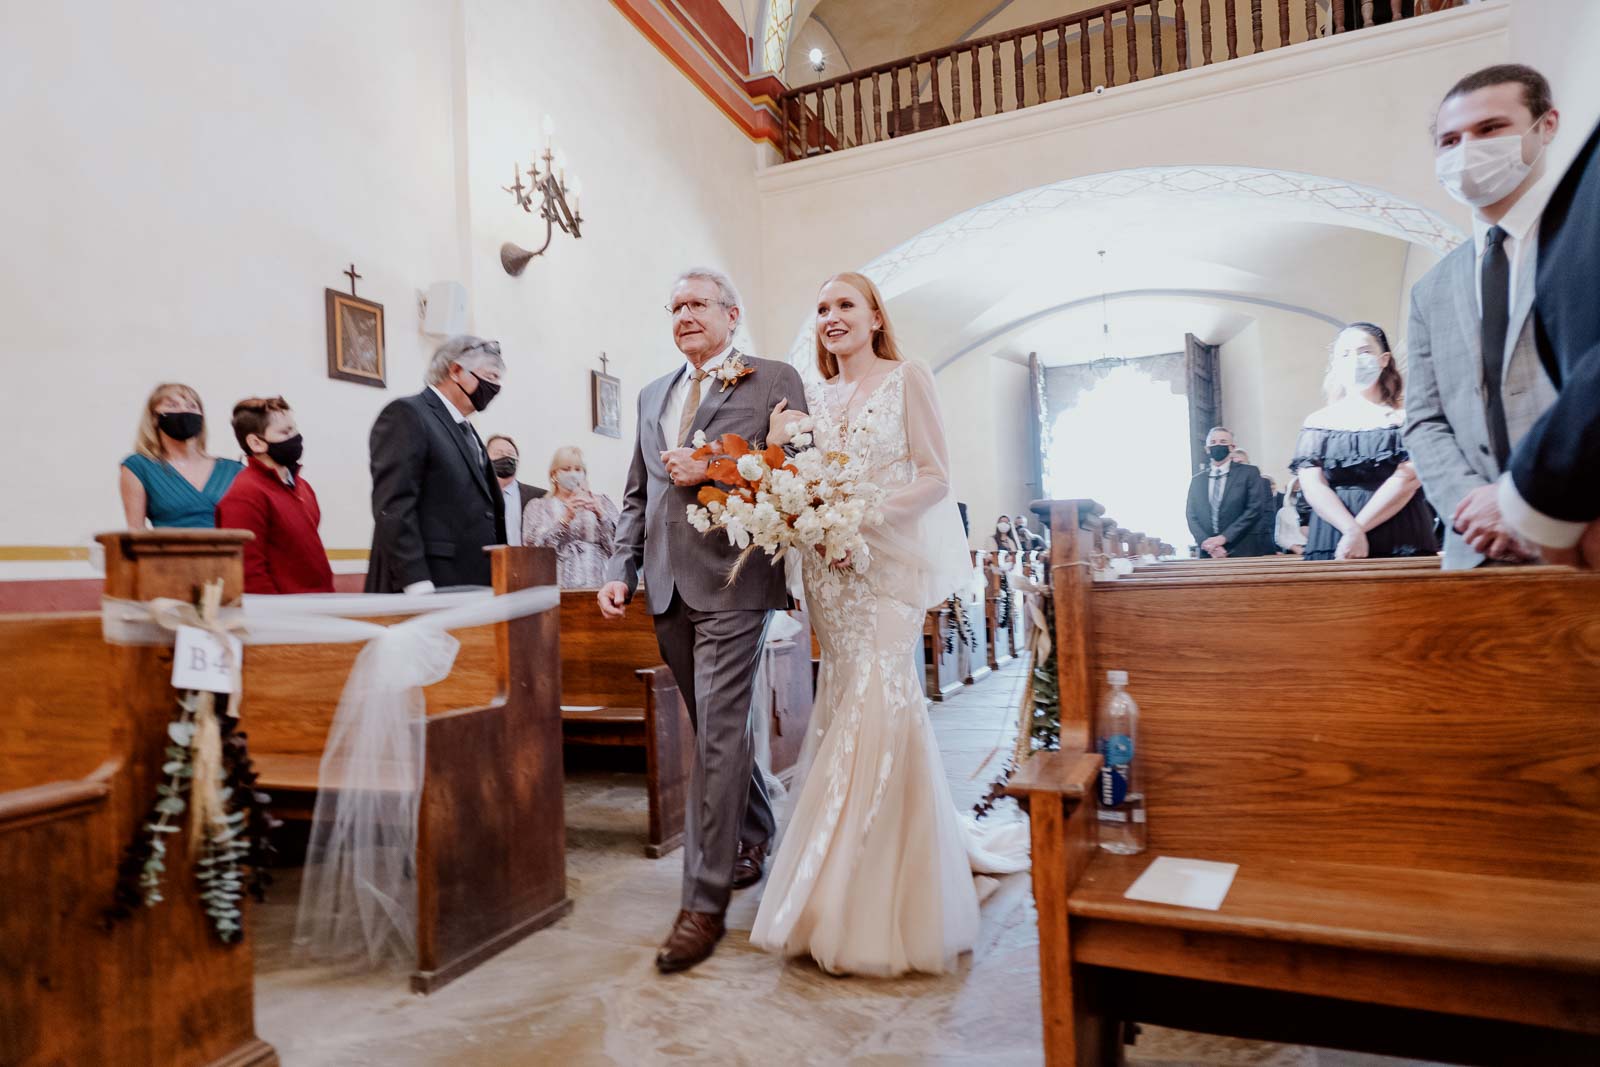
245, 547, 573, 993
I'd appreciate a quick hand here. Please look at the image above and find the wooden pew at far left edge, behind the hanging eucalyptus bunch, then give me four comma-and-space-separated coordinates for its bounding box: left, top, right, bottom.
0, 530, 278, 1067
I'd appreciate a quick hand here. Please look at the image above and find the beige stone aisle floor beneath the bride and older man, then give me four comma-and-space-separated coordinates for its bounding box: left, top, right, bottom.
256, 665, 1440, 1067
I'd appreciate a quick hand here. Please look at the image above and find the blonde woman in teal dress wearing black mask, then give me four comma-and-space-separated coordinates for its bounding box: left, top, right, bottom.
120, 382, 245, 530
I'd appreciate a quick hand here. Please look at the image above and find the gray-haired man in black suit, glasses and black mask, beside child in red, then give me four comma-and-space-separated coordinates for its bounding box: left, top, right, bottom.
366, 338, 506, 593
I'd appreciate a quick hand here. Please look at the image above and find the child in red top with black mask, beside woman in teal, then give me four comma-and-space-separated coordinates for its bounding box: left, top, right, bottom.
216, 397, 333, 593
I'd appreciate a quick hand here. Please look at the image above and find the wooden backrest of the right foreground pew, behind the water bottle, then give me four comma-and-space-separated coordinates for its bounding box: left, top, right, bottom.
1090, 568, 1600, 881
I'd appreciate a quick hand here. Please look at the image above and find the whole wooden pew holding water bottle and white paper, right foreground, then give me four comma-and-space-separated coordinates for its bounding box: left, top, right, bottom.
1008, 502, 1600, 1064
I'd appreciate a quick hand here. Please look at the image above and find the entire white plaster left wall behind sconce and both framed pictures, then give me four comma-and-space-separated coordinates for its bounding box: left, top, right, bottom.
0, 0, 762, 571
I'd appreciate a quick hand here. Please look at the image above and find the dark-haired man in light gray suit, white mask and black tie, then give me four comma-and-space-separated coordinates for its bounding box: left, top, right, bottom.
1405, 64, 1560, 568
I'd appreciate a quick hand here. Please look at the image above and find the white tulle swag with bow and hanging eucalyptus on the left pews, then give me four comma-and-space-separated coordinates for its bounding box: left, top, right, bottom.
101, 585, 560, 965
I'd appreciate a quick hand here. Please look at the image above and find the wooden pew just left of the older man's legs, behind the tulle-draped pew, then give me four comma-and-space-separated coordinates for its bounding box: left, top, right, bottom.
562, 589, 694, 857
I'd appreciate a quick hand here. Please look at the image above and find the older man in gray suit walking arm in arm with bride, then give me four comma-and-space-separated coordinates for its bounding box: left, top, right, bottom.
598, 269, 805, 973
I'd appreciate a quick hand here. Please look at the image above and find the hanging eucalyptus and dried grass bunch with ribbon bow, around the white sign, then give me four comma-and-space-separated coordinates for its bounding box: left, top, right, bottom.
107, 579, 278, 944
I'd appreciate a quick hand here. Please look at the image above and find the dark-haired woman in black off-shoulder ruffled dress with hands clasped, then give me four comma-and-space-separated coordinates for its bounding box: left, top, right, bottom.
1290, 323, 1438, 560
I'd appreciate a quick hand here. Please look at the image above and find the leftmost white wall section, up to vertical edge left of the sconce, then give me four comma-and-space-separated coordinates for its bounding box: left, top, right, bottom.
0, 0, 461, 559
